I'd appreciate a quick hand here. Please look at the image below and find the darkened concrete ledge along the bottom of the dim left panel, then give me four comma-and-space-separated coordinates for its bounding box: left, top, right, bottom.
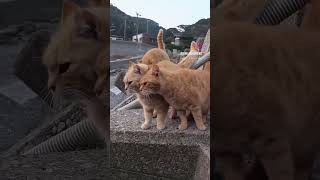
0, 149, 110, 180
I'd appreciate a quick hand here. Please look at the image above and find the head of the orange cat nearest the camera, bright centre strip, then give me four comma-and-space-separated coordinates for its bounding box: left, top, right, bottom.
139, 65, 161, 95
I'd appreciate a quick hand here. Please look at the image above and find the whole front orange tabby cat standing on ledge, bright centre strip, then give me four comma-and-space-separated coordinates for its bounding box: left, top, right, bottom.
140, 65, 210, 130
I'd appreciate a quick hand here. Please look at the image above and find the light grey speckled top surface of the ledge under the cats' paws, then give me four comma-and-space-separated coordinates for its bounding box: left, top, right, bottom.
110, 109, 210, 145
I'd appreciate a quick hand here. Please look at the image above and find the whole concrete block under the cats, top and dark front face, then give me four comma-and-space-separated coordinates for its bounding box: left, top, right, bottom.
110, 109, 210, 180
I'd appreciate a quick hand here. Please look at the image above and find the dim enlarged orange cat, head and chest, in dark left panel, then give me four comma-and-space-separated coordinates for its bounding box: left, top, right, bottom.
42, 0, 109, 131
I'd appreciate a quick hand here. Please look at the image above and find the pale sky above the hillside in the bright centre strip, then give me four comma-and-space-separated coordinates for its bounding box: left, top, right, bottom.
110, 0, 210, 29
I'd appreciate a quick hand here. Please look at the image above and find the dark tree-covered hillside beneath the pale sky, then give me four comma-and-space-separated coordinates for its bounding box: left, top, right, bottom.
110, 5, 210, 48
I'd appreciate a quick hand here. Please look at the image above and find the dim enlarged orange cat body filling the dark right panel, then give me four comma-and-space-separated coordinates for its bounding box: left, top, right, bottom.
212, 20, 320, 180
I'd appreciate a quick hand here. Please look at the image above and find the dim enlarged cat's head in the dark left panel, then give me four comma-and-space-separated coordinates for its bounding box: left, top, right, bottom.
42, 0, 108, 102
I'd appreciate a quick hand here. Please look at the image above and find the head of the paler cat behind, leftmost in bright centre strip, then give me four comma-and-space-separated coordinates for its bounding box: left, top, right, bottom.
123, 61, 148, 94
